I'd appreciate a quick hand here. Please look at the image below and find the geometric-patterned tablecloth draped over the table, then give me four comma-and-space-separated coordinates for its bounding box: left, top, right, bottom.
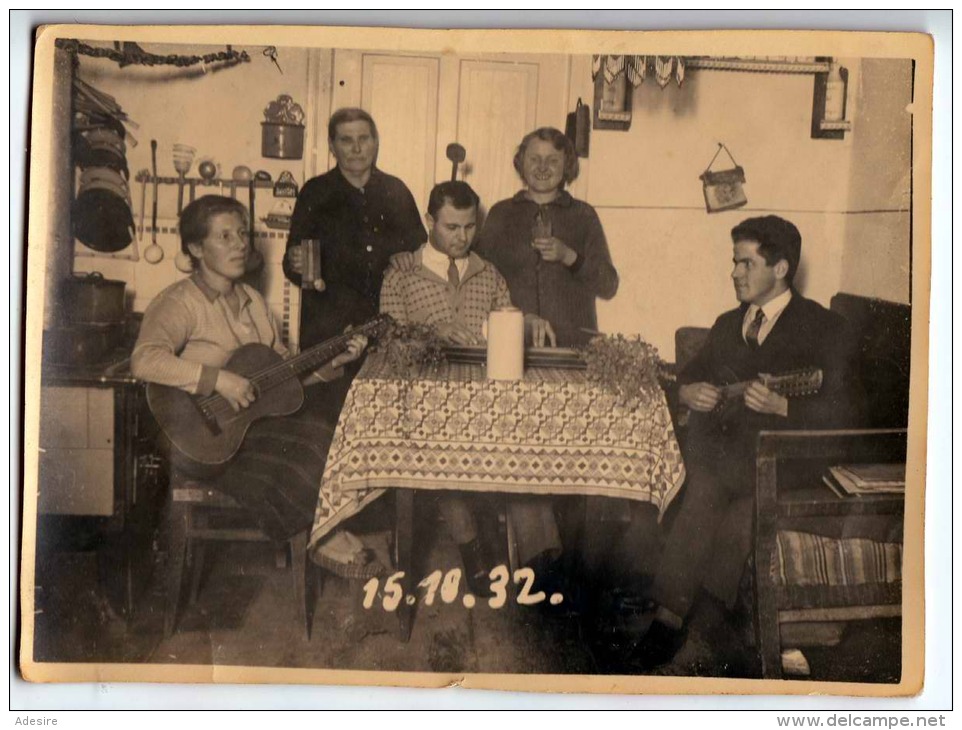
311, 353, 685, 546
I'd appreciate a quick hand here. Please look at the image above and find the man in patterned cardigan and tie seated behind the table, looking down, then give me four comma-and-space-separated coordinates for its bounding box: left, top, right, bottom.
381, 181, 561, 596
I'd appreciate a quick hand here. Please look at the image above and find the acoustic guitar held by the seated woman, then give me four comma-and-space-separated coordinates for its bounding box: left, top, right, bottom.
147, 314, 391, 465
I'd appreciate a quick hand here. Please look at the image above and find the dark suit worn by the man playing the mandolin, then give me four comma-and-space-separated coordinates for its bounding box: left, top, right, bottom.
655, 292, 857, 615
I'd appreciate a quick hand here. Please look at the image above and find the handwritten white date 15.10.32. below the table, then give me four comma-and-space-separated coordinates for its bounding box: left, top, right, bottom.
362, 565, 564, 611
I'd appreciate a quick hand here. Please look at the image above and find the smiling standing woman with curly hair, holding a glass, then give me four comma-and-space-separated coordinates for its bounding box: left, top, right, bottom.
475, 127, 618, 347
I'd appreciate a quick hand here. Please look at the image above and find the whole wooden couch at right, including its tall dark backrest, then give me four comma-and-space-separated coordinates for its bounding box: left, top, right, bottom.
754, 294, 911, 677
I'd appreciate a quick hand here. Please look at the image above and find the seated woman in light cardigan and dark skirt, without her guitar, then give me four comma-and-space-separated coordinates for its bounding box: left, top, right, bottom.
131, 195, 367, 540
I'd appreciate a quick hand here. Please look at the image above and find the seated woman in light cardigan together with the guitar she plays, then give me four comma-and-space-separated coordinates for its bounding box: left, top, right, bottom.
131, 195, 367, 540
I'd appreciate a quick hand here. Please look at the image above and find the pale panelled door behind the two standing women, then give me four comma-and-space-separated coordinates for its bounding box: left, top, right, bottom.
329, 50, 569, 211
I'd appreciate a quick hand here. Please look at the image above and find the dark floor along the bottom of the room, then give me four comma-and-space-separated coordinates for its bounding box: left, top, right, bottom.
35, 524, 900, 682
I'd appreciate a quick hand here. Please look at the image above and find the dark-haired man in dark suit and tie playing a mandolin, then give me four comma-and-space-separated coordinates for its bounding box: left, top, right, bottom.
620, 215, 855, 668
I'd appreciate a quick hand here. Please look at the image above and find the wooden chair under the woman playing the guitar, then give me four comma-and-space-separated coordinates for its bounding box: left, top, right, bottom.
164, 475, 315, 641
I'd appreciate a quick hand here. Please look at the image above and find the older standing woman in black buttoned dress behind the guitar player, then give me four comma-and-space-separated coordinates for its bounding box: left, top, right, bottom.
284, 108, 427, 418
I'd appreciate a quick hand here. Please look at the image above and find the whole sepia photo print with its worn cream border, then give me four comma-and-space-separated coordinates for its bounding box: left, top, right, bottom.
19, 26, 933, 696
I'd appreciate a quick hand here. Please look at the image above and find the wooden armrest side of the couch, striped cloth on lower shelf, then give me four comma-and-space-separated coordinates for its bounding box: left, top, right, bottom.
754, 429, 907, 679
